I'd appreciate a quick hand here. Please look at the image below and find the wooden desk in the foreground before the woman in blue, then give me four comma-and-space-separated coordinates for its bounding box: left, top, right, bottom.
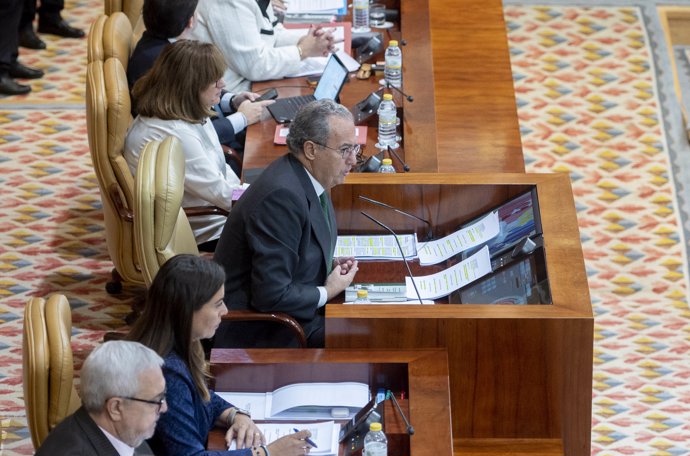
208, 349, 453, 456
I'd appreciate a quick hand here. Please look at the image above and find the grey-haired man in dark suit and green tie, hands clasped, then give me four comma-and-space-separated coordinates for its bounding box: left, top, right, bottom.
214, 100, 359, 347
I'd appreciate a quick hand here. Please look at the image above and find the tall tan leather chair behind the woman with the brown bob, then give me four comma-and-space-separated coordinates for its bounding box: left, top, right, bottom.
86, 58, 143, 284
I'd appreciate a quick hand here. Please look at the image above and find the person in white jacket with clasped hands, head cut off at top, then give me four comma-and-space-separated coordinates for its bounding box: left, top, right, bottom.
191, 0, 335, 92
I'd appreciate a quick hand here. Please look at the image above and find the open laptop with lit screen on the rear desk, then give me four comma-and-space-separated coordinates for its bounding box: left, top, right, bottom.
267, 54, 348, 123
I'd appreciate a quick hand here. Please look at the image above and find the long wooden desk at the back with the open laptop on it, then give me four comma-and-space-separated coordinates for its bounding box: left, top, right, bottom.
244, 0, 524, 173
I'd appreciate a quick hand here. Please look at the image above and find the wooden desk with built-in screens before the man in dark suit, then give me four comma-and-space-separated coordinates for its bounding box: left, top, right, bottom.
326, 174, 594, 456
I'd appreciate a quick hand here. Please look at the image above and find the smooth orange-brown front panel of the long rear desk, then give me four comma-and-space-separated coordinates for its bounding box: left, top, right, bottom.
424, 0, 525, 173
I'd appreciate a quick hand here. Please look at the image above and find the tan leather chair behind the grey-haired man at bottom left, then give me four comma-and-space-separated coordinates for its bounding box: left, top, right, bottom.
22, 294, 81, 448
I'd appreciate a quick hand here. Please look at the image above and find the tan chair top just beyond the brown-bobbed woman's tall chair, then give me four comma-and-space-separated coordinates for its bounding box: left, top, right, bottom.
87, 12, 133, 72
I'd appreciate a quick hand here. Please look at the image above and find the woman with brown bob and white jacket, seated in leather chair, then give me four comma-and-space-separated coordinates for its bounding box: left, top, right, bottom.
124, 40, 250, 251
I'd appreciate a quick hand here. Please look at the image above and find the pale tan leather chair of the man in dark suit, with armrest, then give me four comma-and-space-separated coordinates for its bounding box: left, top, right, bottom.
134, 137, 307, 347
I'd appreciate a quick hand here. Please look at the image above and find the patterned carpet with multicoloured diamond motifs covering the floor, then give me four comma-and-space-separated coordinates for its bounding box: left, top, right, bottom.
0, 0, 690, 455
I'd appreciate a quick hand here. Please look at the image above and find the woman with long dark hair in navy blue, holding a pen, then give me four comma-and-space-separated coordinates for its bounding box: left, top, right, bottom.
127, 255, 310, 456
